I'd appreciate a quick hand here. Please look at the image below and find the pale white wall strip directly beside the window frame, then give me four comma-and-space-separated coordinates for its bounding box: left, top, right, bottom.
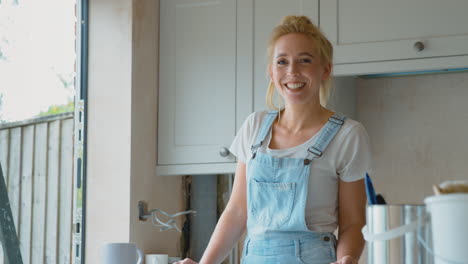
85, 0, 132, 263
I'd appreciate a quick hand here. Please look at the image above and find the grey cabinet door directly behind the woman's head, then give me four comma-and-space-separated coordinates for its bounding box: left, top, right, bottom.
249, 0, 319, 111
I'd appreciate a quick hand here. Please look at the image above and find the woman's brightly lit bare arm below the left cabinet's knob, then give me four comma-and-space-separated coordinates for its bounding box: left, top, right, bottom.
182, 161, 247, 264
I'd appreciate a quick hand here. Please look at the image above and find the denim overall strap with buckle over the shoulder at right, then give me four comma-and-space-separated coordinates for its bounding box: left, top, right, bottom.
305, 113, 346, 160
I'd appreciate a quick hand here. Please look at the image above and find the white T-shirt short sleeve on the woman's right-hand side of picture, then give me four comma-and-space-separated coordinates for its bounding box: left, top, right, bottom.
337, 123, 373, 182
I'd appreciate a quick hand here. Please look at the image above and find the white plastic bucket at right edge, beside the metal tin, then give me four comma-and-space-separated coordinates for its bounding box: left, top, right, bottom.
424, 193, 468, 264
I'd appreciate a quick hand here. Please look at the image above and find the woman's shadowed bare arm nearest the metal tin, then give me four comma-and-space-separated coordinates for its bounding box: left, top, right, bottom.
330, 180, 366, 264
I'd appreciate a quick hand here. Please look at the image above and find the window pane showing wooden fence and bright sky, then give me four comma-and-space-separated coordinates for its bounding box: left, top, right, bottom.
0, 0, 76, 264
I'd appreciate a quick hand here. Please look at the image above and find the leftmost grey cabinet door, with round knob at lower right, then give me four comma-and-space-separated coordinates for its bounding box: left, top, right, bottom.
158, 0, 236, 165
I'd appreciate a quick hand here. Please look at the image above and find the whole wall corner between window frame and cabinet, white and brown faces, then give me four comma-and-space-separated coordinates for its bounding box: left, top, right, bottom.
85, 0, 184, 263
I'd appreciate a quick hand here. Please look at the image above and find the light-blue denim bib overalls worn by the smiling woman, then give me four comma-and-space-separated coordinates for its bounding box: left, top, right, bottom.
242, 111, 345, 264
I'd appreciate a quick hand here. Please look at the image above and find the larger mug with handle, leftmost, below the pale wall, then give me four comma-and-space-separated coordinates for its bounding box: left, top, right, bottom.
102, 243, 143, 264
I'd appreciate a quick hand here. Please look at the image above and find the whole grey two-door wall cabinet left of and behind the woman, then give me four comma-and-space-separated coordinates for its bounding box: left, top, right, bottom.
156, 0, 318, 175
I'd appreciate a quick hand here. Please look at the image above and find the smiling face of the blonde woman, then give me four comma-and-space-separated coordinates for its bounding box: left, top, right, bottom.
269, 33, 331, 105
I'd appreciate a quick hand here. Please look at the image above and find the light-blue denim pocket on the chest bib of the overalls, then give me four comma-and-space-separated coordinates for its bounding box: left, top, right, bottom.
249, 179, 296, 228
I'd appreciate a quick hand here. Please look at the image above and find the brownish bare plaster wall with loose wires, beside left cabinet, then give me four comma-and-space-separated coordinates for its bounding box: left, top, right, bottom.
130, 0, 185, 256
